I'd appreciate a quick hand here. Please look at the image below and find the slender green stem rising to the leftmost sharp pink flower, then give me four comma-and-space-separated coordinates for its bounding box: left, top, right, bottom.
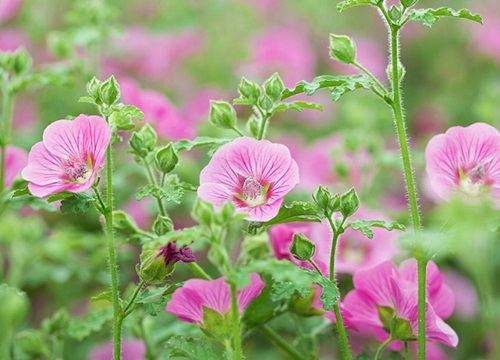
104, 144, 123, 360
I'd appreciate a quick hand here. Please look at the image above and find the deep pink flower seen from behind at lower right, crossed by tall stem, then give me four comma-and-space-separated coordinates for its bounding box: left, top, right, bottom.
344, 260, 458, 349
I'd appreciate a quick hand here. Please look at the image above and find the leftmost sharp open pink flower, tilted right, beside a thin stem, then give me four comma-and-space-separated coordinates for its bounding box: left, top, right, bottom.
22, 115, 111, 197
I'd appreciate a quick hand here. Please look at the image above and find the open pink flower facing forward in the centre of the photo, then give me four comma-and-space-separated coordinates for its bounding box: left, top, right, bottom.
198, 137, 299, 221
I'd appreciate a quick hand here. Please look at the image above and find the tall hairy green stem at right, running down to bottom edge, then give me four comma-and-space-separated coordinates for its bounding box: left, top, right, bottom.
382, 23, 427, 360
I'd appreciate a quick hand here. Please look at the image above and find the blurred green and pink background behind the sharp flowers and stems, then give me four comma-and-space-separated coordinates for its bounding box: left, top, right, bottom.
0, 0, 500, 360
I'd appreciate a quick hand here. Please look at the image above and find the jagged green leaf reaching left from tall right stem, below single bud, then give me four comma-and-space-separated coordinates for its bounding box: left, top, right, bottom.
281, 75, 373, 101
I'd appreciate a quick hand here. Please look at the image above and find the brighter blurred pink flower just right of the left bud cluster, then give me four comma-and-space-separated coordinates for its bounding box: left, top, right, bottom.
120, 79, 196, 140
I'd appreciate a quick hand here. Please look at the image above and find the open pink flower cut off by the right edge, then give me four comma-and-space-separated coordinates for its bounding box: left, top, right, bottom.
425, 123, 500, 201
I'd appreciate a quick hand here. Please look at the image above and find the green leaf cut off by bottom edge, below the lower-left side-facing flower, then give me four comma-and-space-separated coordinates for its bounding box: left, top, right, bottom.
165, 335, 222, 360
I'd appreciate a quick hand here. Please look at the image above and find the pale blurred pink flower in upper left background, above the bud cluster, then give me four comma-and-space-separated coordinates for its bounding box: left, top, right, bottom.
104, 27, 204, 82
